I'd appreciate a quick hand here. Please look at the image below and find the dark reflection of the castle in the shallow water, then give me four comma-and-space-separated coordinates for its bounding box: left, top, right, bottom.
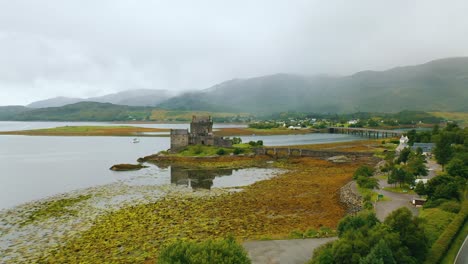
171, 166, 232, 190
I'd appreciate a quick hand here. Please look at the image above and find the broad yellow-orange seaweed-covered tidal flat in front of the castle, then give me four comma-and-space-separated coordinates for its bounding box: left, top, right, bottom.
0, 155, 372, 263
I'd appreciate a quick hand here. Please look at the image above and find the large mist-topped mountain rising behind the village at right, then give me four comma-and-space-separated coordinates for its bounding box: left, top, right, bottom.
159, 57, 468, 113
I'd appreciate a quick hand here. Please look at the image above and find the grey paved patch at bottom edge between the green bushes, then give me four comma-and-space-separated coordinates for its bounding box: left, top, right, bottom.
244, 237, 336, 264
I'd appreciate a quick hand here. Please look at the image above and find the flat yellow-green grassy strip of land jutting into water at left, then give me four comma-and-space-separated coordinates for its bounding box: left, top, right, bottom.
0, 126, 169, 136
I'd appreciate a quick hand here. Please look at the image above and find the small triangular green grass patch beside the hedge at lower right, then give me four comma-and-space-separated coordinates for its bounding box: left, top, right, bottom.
419, 208, 457, 245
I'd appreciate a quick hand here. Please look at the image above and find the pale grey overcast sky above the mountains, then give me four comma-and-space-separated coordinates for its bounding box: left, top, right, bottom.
0, 0, 468, 105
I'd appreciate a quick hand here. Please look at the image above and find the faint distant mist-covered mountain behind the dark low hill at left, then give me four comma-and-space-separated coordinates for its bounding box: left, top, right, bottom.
27, 89, 169, 108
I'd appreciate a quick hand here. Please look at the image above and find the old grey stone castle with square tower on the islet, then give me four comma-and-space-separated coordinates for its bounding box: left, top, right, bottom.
171, 116, 232, 151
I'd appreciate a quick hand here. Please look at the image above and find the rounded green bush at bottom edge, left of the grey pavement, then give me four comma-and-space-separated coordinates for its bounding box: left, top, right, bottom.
158, 238, 251, 264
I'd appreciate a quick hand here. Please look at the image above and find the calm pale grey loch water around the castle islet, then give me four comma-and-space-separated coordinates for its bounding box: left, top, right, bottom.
0, 122, 360, 209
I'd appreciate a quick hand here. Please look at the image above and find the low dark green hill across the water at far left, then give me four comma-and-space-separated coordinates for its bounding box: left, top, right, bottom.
9, 102, 154, 121
